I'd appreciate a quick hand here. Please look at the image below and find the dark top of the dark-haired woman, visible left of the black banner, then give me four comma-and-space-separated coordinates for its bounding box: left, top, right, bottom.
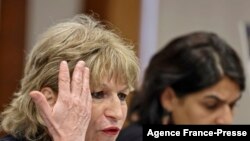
116, 123, 143, 141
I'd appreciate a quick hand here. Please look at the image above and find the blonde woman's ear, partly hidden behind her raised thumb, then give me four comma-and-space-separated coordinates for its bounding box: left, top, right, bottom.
41, 87, 57, 107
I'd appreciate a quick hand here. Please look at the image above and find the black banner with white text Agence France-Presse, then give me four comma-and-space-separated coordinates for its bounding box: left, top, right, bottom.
143, 125, 250, 141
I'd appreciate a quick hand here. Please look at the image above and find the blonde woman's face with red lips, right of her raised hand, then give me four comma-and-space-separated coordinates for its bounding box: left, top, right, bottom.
86, 79, 129, 141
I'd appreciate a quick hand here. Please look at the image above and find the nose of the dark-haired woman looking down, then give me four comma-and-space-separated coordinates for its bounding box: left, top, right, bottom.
216, 105, 233, 124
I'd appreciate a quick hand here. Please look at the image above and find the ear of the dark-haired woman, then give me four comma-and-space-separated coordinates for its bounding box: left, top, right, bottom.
160, 87, 177, 112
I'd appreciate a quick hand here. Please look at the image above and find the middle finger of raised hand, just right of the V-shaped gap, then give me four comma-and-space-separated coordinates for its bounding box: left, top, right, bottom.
71, 61, 85, 97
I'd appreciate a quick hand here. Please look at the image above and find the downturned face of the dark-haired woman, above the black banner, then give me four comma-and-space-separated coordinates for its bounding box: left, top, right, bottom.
172, 77, 241, 124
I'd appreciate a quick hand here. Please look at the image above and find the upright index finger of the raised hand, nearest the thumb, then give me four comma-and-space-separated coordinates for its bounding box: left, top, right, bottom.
58, 61, 70, 99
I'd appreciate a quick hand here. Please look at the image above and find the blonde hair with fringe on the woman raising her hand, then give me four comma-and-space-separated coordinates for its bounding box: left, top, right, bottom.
1, 14, 139, 141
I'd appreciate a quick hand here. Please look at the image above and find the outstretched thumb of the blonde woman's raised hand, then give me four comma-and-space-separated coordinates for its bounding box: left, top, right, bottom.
30, 91, 52, 127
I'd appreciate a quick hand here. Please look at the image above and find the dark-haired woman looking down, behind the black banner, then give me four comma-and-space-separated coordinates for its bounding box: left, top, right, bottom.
118, 32, 245, 141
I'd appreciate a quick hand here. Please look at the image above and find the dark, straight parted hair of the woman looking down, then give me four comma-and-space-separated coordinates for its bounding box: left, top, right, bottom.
130, 32, 245, 124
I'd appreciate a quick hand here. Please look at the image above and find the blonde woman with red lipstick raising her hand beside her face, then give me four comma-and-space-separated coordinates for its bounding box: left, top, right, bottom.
0, 14, 139, 141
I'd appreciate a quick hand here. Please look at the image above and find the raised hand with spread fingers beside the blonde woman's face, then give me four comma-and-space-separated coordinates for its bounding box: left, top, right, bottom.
30, 61, 92, 141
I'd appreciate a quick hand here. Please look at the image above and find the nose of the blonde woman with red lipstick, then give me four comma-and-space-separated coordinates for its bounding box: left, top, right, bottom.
104, 96, 123, 121
